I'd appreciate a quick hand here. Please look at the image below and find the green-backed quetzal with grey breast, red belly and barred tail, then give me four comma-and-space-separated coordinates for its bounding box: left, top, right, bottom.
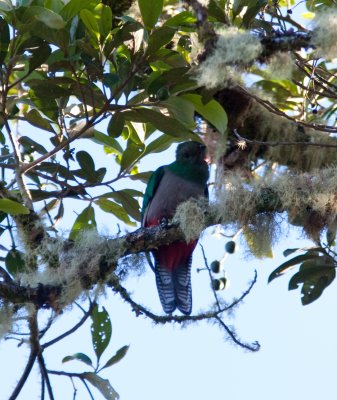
142, 141, 209, 315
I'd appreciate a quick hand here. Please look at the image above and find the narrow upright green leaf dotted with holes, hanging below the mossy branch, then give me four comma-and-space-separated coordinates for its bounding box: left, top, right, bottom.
91, 304, 112, 363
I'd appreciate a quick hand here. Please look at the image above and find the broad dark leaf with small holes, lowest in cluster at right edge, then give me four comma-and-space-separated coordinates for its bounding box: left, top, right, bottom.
289, 257, 336, 305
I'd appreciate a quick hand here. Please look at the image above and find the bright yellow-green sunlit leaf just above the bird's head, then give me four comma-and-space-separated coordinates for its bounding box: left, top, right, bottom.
182, 94, 228, 134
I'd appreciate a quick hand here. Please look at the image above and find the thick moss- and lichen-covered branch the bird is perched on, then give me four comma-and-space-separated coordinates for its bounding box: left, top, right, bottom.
0, 163, 337, 311
